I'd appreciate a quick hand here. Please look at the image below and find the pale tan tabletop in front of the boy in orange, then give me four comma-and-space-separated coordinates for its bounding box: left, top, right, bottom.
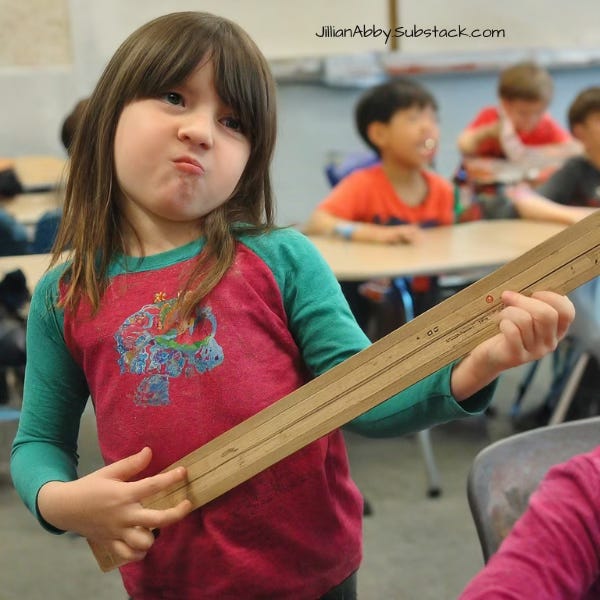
310, 219, 564, 281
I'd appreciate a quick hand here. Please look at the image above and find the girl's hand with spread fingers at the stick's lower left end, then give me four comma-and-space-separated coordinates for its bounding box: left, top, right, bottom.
38, 448, 192, 562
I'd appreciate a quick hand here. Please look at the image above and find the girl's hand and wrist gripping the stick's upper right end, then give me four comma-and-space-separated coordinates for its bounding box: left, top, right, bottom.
451, 292, 575, 401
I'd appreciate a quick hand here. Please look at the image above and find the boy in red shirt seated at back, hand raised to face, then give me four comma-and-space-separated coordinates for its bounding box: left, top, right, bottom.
455, 62, 580, 221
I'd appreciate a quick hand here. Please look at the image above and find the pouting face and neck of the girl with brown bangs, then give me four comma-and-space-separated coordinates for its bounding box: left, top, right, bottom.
114, 61, 250, 255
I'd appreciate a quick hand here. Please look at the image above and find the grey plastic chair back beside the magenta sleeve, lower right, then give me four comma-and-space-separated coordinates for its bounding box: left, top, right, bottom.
467, 417, 600, 562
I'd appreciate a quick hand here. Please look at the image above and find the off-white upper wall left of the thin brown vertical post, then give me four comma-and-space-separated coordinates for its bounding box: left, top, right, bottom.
0, 0, 387, 156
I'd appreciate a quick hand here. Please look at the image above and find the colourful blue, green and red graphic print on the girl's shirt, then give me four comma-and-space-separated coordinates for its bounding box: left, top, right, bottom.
114, 293, 224, 406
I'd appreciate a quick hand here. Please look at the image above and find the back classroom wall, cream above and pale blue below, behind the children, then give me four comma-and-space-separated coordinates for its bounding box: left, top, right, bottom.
0, 0, 600, 225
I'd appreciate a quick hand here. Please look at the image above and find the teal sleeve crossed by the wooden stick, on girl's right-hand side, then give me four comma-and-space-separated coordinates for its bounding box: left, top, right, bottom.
241, 229, 495, 437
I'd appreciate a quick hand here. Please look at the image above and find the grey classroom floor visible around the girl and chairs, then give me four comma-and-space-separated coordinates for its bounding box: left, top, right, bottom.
0, 360, 545, 600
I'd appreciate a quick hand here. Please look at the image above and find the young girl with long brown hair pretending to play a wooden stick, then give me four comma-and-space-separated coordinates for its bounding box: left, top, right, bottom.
12, 13, 573, 600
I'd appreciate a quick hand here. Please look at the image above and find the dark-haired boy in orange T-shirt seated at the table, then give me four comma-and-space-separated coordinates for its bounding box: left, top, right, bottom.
307, 79, 454, 329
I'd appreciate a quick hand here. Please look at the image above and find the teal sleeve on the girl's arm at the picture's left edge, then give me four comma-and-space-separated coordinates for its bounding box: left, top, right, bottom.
11, 270, 89, 531
